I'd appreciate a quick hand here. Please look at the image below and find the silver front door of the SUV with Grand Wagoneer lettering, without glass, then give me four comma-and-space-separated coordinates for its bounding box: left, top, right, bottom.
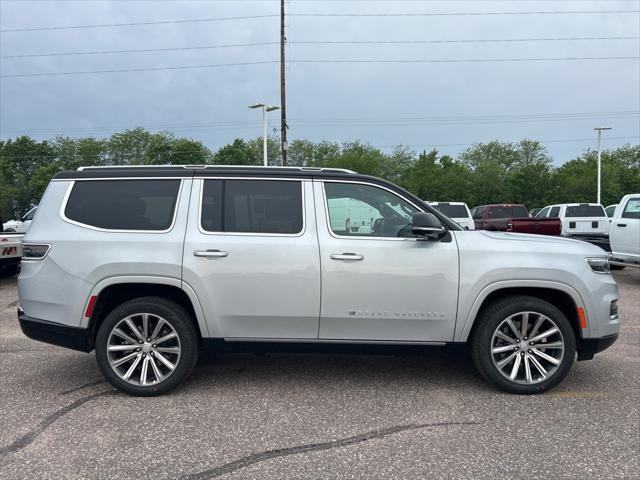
314, 181, 458, 342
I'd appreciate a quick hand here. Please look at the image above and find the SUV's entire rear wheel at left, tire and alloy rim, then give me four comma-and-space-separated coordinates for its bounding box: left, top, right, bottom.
95, 297, 198, 396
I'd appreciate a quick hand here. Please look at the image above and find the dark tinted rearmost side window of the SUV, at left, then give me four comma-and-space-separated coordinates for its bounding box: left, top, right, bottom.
64, 179, 180, 231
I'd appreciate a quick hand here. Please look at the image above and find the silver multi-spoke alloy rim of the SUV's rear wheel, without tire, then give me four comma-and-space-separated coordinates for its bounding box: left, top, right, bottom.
107, 313, 181, 386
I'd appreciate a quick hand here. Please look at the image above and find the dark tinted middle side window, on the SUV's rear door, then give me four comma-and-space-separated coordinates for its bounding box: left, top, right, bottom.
200, 180, 303, 235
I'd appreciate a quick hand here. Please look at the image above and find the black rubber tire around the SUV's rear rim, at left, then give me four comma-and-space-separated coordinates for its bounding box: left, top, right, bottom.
95, 297, 199, 397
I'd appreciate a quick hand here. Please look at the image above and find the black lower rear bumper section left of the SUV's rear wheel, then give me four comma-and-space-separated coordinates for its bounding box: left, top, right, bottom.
18, 309, 93, 352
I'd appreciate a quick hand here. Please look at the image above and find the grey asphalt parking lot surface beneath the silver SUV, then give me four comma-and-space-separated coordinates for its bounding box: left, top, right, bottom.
0, 268, 640, 480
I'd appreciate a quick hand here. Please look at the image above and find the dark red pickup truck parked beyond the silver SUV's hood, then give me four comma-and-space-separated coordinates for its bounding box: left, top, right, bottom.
471, 203, 562, 235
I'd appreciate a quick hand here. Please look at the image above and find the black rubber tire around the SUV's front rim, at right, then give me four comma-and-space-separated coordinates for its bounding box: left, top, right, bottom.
470, 295, 576, 394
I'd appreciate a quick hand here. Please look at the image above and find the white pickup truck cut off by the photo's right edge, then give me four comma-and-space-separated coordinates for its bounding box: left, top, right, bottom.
609, 193, 640, 267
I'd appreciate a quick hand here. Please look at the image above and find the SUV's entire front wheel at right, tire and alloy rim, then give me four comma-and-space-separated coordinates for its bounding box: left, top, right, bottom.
471, 296, 576, 394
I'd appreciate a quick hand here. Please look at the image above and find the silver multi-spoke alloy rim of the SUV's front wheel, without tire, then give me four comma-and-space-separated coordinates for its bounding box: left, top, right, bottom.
491, 312, 565, 385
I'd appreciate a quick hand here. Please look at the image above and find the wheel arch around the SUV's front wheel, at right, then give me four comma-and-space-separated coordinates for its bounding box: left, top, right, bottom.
456, 281, 585, 342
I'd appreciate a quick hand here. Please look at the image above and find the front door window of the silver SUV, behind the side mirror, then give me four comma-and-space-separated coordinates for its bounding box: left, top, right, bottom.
324, 182, 418, 237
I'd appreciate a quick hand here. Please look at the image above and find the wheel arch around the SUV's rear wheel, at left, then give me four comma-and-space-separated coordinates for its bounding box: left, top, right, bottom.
82, 277, 208, 346
